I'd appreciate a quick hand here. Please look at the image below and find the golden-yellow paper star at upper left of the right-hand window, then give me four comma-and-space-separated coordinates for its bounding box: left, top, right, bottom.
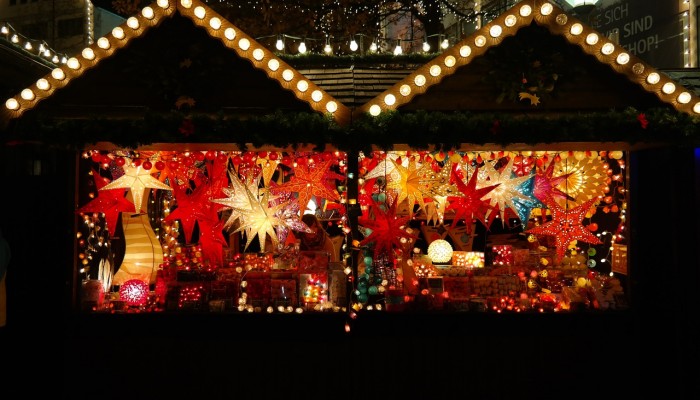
386, 159, 435, 216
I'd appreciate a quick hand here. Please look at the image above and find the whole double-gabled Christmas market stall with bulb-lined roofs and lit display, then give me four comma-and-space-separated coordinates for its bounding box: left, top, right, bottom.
2, 0, 700, 322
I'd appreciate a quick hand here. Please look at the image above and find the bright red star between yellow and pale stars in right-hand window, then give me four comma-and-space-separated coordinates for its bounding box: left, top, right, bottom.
446, 167, 499, 233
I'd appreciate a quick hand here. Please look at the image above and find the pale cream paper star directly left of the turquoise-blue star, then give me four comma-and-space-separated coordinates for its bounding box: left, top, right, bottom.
477, 158, 533, 224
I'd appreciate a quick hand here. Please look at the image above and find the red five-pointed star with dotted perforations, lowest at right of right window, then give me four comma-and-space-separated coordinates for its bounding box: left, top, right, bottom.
526, 197, 602, 257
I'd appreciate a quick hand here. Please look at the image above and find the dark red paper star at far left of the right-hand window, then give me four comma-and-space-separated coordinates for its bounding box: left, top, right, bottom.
358, 203, 417, 256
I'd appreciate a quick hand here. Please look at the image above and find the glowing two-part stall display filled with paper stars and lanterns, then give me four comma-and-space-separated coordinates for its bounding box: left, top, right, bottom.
75, 148, 628, 314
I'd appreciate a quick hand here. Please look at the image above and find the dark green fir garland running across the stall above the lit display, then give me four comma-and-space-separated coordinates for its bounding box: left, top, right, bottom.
0, 108, 700, 151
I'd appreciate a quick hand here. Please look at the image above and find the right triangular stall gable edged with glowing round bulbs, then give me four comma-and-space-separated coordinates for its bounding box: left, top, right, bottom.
355, 0, 700, 115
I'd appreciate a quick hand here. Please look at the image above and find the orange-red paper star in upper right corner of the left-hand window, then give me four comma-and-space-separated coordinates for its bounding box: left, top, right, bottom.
272, 160, 340, 210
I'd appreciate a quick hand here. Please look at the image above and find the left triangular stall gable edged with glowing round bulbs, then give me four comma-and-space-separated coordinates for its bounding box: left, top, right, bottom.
0, 0, 349, 126
